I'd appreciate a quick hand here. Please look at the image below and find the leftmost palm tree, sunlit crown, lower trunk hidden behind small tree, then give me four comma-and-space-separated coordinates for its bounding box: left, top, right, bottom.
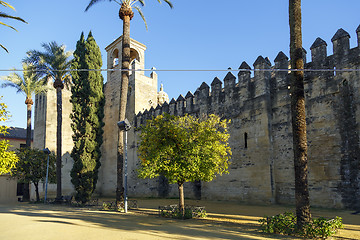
1, 63, 47, 201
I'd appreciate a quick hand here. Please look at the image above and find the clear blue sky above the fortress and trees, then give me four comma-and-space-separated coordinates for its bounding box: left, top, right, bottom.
0, 0, 360, 127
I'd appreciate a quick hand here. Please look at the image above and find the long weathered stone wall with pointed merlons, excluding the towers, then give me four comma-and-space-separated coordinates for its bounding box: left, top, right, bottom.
129, 26, 360, 208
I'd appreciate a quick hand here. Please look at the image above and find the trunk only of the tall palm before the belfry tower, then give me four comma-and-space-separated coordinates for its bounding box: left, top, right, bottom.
116, 5, 133, 206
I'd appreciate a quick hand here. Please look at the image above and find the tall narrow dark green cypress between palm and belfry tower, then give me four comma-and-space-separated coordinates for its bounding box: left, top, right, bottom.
70, 32, 105, 204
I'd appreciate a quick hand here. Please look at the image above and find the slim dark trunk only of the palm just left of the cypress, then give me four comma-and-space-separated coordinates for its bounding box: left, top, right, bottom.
54, 79, 64, 201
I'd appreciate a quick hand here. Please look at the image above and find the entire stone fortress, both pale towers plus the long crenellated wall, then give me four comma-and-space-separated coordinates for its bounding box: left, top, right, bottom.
34, 26, 360, 208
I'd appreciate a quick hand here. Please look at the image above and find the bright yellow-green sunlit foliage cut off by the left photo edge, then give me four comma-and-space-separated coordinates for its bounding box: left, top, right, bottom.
0, 97, 19, 175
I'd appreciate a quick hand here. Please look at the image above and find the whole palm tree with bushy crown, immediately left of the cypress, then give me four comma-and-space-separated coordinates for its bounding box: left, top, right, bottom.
24, 42, 72, 200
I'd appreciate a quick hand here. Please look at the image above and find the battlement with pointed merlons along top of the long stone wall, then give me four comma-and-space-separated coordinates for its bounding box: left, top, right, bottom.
135, 25, 360, 127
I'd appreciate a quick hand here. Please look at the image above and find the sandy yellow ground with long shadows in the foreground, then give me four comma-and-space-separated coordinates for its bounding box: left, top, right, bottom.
0, 199, 360, 240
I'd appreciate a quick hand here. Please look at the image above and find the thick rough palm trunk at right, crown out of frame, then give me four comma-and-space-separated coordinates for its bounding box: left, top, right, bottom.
289, 0, 311, 228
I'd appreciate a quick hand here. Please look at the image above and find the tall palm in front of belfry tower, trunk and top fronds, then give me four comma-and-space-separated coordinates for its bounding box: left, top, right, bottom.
85, 0, 173, 206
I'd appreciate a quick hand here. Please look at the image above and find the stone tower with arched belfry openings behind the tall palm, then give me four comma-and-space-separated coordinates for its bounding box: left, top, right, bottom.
97, 37, 157, 196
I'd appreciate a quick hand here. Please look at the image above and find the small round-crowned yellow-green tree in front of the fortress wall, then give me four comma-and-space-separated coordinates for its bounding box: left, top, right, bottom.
139, 114, 231, 216
